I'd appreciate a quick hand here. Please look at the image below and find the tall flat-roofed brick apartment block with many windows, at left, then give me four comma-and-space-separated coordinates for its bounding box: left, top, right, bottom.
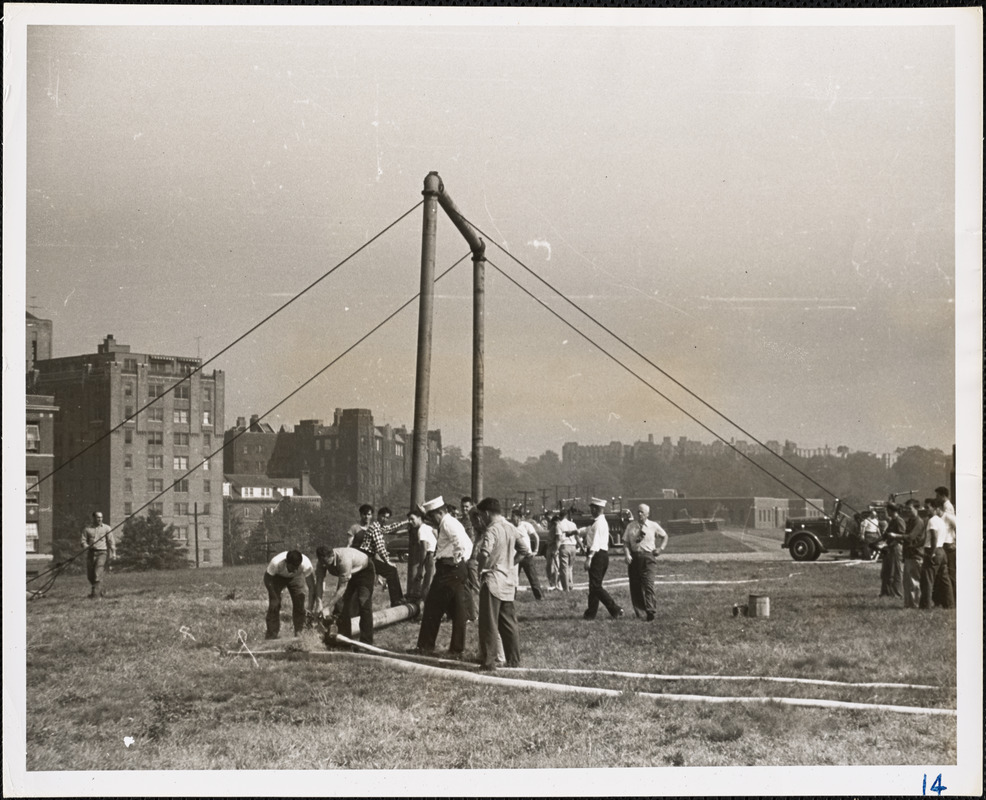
33, 335, 225, 566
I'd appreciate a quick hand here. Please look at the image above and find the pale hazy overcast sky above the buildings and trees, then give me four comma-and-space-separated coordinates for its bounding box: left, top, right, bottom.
7, 9, 976, 458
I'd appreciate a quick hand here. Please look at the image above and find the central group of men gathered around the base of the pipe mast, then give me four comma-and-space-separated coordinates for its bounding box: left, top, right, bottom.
264, 497, 668, 670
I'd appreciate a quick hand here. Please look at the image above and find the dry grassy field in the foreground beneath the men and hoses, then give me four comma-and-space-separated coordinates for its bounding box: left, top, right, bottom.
26, 554, 956, 770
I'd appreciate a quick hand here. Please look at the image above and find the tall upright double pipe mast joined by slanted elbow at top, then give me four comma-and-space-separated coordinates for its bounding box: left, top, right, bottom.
411, 172, 486, 505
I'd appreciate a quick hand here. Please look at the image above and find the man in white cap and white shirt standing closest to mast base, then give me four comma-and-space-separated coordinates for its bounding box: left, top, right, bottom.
417, 497, 472, 658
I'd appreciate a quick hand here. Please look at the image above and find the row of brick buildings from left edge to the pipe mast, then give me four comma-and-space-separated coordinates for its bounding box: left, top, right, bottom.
25, 313, 442, 574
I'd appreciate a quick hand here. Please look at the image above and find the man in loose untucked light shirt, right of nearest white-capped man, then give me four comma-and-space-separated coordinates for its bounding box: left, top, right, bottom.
477, 497, 531, 670
